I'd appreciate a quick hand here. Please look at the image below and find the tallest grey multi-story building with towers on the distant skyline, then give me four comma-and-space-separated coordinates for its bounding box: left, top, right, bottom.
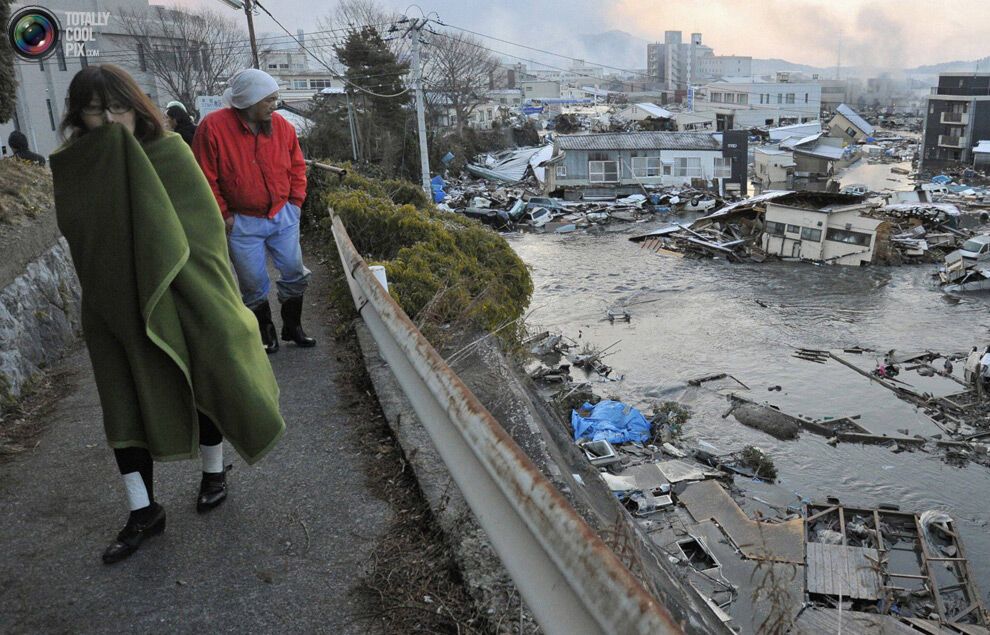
646, 31, 753, 91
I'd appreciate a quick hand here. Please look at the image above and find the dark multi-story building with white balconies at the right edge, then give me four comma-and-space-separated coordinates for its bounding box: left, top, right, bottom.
921, 73, 990, 168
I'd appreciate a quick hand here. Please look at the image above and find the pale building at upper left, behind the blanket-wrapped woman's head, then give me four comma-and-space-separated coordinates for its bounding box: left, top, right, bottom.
0, 0, 184, 156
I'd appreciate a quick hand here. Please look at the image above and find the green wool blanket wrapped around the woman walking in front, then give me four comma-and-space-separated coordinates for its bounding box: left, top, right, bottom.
51, 124, 285, 463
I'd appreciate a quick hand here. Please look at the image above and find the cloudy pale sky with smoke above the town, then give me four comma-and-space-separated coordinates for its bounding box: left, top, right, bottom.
178, 0, 990, 70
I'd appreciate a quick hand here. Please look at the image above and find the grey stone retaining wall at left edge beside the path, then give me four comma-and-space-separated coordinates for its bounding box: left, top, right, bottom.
0, 210, 80, 414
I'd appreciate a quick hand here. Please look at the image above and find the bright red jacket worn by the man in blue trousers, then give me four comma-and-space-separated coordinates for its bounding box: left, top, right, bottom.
193, 108, 306, 218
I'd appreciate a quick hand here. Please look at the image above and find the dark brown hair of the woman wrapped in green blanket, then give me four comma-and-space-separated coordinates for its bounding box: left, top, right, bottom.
59, 64, 165, 143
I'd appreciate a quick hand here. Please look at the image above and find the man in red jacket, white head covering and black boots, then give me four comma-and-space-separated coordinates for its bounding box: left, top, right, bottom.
193, 68, 316, 353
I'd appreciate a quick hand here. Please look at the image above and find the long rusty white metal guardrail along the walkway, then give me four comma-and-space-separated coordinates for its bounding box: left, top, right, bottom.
333, 216, 682, 635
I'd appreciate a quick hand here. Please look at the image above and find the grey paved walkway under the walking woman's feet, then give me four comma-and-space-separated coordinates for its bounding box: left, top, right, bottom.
0, 259, 391, 633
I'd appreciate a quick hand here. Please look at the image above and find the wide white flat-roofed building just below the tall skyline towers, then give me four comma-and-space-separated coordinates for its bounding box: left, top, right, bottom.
694, 77, 821, 130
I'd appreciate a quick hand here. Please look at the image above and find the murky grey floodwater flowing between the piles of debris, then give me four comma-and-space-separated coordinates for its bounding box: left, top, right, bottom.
509, 230, 990, 592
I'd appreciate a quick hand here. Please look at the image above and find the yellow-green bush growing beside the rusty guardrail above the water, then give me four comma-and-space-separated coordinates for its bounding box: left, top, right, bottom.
309, 164, 533, 334
